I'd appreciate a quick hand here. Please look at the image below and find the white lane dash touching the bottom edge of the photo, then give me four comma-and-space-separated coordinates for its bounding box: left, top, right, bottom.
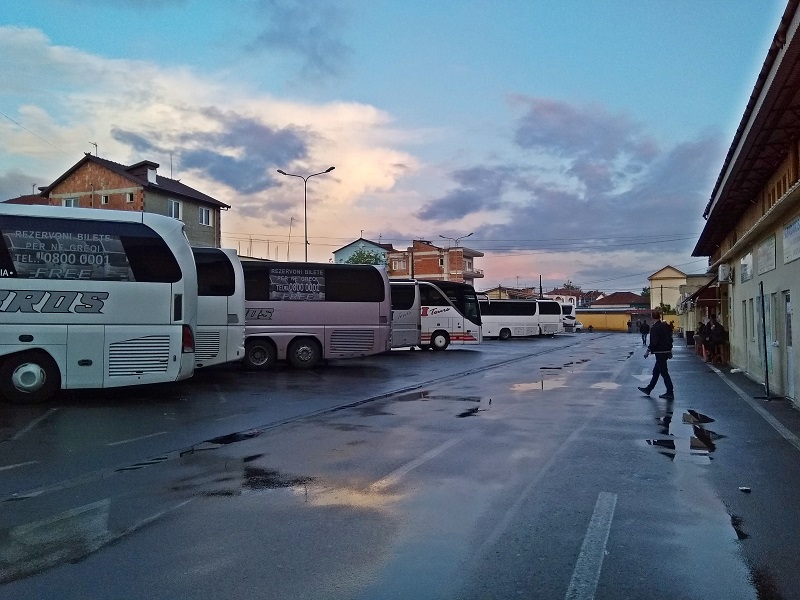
566, 492, 617, 600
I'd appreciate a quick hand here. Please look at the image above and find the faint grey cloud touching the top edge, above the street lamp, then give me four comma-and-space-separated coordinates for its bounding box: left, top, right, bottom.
248, 0, 352, 81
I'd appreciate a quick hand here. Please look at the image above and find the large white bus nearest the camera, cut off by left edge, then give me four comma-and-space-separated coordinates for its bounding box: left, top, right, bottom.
0, 204, 197, 403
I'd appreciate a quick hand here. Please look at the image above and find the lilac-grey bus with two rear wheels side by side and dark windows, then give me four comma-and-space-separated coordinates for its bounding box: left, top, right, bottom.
242, 261, 392, 370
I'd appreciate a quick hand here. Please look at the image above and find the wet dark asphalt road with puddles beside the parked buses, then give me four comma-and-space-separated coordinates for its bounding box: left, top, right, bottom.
0, 333, 800, 599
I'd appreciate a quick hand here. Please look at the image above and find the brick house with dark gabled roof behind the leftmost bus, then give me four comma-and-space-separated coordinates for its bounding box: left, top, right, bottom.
30, 154, 230, 247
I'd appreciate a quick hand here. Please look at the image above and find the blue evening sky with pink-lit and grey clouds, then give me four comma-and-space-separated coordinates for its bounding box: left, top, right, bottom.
0, 0, 786, 292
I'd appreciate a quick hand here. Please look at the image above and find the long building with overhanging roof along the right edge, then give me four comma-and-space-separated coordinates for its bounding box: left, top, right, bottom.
692, 0, 800, 403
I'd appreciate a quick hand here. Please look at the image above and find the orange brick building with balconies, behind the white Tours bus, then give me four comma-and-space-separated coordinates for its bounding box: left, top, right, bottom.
388, 240, 483, 286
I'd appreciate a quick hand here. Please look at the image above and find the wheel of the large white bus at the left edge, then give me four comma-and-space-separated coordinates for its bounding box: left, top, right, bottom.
0, 351, 61, 404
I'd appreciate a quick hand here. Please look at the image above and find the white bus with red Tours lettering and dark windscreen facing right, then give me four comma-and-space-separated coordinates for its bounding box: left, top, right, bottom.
418, 280, 481, 350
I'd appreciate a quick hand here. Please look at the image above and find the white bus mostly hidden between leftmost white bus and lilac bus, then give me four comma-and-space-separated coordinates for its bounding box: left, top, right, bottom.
192, 248, 244, 368
